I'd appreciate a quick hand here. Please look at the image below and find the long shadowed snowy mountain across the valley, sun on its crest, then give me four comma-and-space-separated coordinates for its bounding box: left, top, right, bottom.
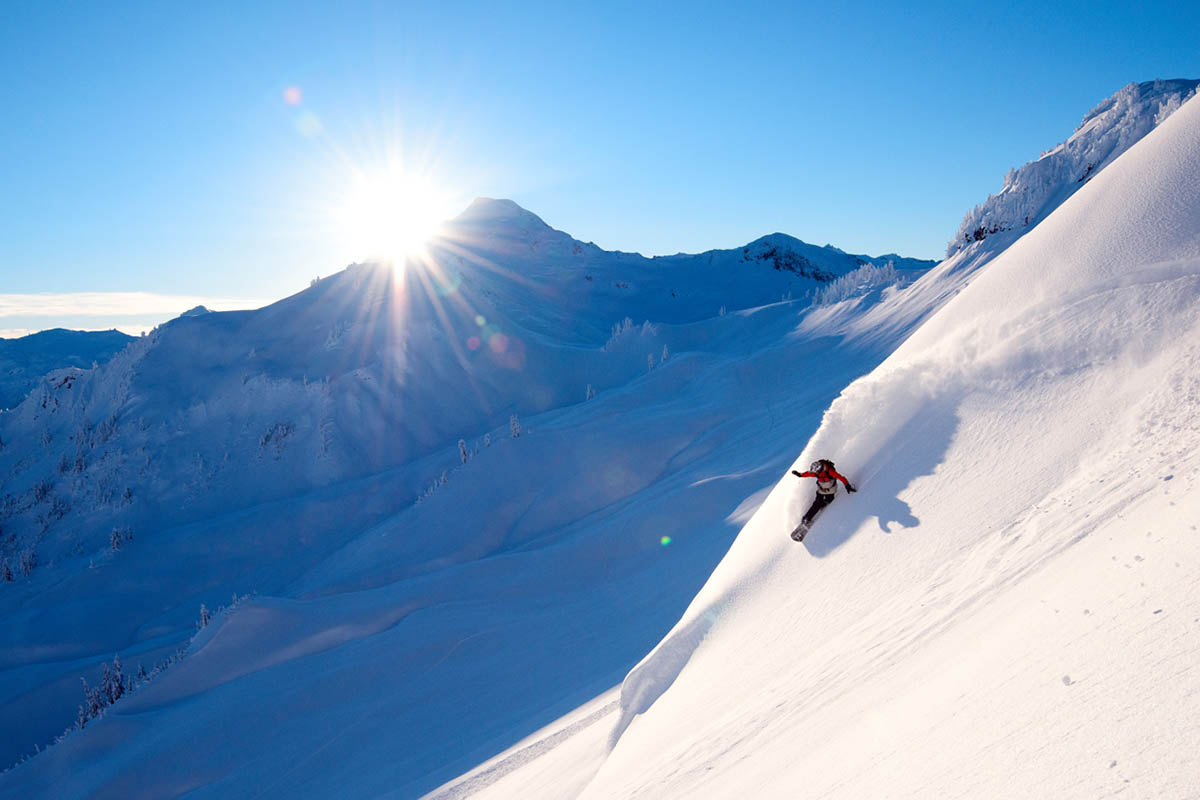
0, 214, 932, 582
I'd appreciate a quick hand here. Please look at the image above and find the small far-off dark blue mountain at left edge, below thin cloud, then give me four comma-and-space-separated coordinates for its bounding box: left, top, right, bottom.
0, 327, 133, 409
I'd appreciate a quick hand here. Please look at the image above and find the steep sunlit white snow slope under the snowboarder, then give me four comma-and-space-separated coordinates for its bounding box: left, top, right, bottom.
552, 92, 1200, 798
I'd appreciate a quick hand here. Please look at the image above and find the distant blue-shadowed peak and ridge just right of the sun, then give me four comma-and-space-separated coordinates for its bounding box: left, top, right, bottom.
430, 198, 936, 345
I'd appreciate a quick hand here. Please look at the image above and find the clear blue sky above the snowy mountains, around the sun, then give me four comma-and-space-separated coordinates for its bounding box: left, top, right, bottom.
0, 1, 1200, 330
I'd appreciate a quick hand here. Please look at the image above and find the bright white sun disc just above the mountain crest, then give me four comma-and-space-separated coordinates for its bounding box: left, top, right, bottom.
338, 167, 449, 270
